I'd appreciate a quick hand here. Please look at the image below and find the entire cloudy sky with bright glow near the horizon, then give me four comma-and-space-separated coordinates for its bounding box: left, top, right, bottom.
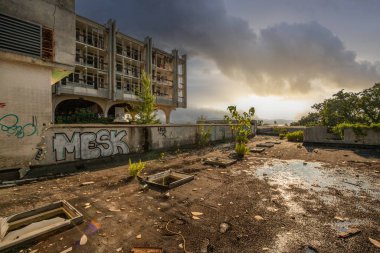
76, 0, 380, 121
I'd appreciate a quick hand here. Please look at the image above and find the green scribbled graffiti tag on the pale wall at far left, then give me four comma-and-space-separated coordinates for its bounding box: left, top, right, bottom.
0, 114, 37, 139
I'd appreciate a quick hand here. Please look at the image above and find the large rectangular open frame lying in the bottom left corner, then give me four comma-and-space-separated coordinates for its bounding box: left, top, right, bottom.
0, 200, 83, 251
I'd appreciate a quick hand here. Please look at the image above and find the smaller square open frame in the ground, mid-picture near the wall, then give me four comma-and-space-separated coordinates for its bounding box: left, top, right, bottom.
142, 170, 194, 189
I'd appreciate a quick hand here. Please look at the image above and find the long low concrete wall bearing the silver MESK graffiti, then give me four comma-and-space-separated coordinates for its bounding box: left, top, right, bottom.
25, 124, 243, 166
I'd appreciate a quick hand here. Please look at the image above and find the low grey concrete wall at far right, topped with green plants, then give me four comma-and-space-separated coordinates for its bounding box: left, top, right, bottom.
304, 126, 380, 146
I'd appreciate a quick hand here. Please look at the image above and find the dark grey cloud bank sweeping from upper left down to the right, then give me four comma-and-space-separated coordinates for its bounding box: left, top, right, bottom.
77, 0, 380, 95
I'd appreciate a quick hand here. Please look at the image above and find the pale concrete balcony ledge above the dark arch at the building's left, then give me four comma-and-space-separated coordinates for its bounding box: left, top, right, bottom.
56, 82, 108, 98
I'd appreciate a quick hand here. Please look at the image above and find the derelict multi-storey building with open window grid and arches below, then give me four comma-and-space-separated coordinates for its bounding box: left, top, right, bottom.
53, 16, 187, 123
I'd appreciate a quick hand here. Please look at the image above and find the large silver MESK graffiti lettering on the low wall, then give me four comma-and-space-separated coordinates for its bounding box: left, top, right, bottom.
53, 129, 129, 161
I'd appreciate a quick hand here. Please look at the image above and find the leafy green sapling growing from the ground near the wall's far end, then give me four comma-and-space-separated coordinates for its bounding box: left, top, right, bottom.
224, 106, 255, 157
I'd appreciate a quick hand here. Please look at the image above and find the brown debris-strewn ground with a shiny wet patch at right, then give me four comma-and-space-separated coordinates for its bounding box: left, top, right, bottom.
0, 136, 380, 253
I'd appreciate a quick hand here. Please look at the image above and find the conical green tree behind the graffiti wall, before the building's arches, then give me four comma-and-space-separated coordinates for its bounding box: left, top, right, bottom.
136, 71, 159, 124
